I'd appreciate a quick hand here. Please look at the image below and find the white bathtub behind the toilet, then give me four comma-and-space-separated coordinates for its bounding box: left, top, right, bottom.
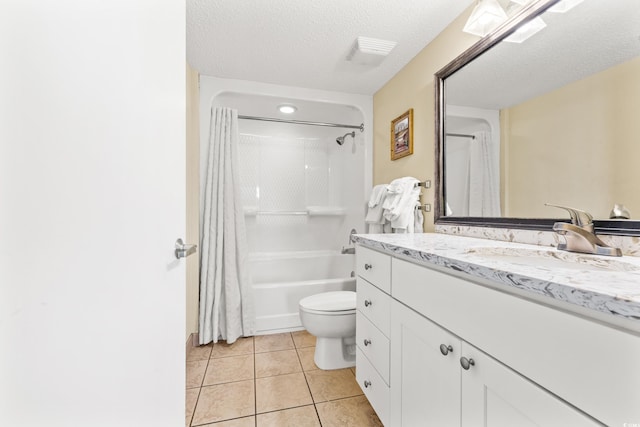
249, 251, 356, 335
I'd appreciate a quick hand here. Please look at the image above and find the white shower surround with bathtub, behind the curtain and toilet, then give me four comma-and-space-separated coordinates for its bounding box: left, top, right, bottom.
200, 76, 372, 334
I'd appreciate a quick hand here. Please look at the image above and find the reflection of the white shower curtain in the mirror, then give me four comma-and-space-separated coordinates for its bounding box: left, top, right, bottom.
469, 131, 500, 217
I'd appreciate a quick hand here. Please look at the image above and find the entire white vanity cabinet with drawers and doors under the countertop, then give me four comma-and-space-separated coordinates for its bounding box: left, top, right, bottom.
356, 246, 640, 427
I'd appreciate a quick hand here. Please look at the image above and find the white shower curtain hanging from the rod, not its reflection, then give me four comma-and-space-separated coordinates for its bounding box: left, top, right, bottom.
199, 108, 255, 344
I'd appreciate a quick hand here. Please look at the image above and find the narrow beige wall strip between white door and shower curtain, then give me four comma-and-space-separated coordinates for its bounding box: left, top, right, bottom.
186, 64, 200, 338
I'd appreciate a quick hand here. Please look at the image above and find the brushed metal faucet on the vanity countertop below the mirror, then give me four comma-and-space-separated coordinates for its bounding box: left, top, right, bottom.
545, 203, 622, 256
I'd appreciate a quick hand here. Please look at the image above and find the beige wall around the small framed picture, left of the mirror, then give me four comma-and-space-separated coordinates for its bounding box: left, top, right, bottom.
373, 5, 478, 231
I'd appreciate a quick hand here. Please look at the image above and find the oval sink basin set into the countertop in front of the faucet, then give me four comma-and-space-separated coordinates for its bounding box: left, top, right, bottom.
465, 247, 640, 271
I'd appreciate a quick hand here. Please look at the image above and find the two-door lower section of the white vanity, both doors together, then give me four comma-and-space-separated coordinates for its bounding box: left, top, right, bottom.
390, 301, 600, 427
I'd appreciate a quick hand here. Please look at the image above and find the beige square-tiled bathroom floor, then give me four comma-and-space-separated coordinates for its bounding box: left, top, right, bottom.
185, 331, 382, 427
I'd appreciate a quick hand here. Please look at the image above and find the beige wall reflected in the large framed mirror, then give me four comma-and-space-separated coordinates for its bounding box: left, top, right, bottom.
501, 58, 640, 218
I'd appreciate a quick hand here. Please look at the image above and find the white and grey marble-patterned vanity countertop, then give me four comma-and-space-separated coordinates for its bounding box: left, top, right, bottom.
354, 233, 640, 329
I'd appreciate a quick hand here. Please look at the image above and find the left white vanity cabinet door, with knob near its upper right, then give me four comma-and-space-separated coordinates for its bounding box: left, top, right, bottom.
390, 301, 461, 427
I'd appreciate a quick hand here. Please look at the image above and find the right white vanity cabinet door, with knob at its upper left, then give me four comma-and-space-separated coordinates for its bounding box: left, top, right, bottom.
458, 342, 603, 427
